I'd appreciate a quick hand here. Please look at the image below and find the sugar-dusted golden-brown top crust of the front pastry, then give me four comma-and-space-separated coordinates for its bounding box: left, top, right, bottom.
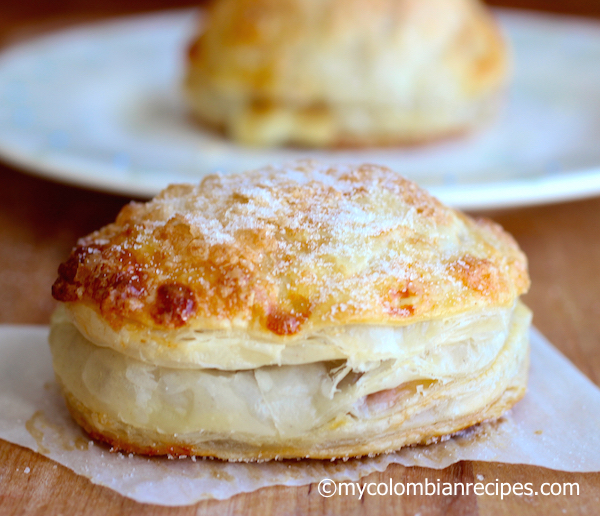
53, 162, 529, 337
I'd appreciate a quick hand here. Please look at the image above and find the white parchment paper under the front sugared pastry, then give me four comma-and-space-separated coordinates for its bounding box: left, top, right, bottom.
0, 326, 600, 505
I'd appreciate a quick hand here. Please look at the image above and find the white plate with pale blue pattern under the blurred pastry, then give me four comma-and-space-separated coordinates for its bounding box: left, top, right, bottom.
0, 10, 600, 209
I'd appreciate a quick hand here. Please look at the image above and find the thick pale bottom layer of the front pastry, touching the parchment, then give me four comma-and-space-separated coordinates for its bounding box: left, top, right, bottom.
51, 304, 530, 460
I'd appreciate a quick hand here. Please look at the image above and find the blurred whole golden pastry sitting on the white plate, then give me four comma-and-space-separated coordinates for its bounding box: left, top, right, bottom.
185, 0, 508, 147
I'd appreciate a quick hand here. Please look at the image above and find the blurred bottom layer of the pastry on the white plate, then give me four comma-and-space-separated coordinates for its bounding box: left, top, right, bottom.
186, 80, 504, 148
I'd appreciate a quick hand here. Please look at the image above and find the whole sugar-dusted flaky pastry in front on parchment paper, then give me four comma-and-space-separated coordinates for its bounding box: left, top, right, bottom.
50, 161, 530, 460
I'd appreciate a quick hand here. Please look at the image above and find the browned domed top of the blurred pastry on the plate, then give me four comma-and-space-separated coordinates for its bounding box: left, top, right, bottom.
189, 0, 508, 107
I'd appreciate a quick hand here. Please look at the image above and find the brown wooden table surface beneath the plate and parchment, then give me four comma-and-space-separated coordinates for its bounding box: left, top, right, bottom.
0, 0, 600, 516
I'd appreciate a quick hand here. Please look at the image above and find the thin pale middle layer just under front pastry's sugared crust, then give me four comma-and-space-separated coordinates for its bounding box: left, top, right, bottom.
61, 304, 514, 371
